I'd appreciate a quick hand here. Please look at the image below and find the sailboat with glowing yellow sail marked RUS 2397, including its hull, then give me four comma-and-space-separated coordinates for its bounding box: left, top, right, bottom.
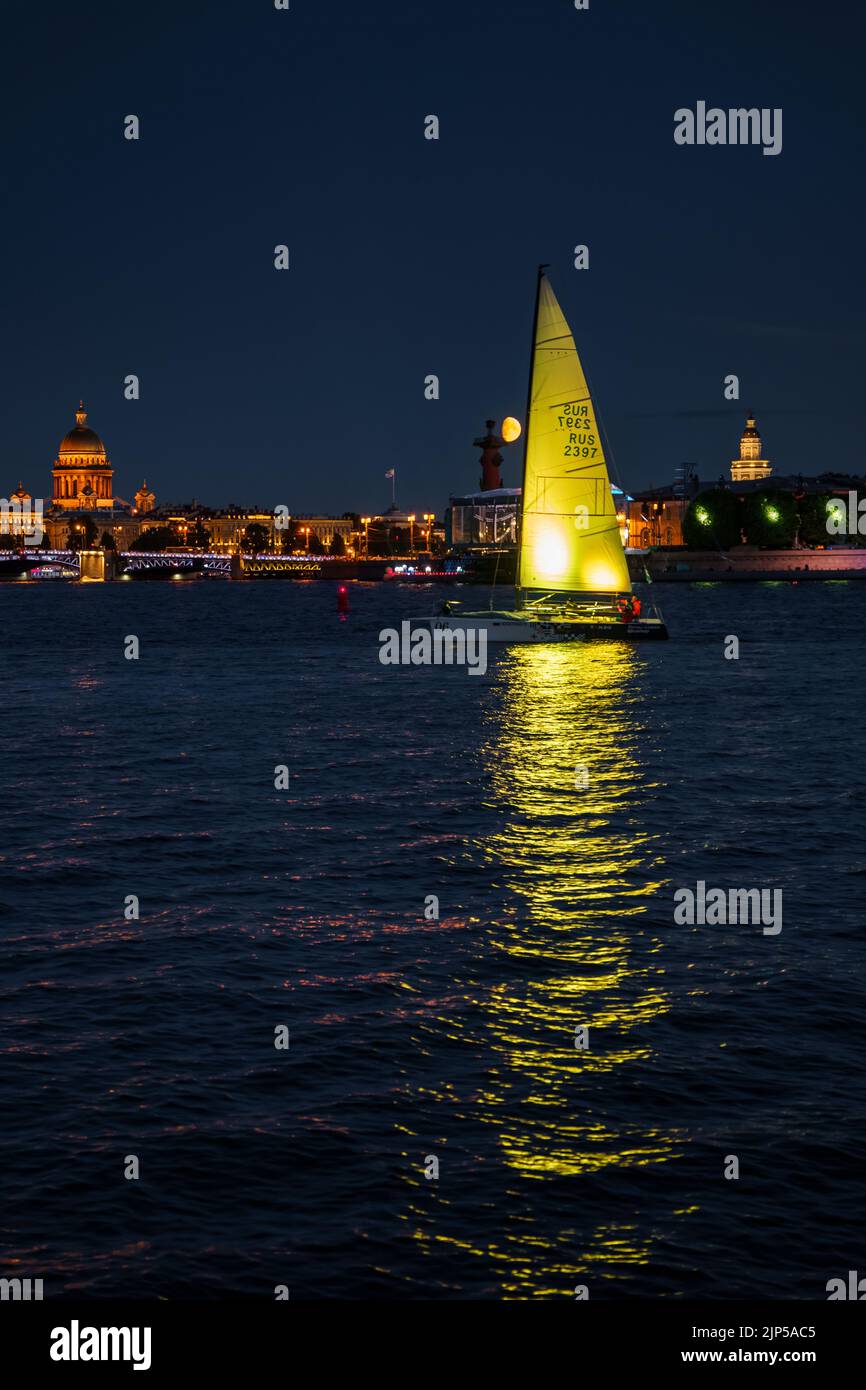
428, 265, 667, 642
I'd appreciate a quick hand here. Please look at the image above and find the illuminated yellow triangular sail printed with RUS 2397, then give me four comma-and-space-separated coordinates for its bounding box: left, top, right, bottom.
517, 275, 631, 596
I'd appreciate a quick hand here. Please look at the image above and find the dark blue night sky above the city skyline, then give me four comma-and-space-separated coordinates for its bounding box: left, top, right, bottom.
0, 0, 866, 514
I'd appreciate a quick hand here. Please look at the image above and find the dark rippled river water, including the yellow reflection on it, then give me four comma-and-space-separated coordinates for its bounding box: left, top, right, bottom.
0, 582, 866, 1298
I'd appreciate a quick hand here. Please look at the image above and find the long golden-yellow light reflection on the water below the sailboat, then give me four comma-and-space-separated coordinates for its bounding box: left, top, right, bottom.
405, 644, 680, 1297
